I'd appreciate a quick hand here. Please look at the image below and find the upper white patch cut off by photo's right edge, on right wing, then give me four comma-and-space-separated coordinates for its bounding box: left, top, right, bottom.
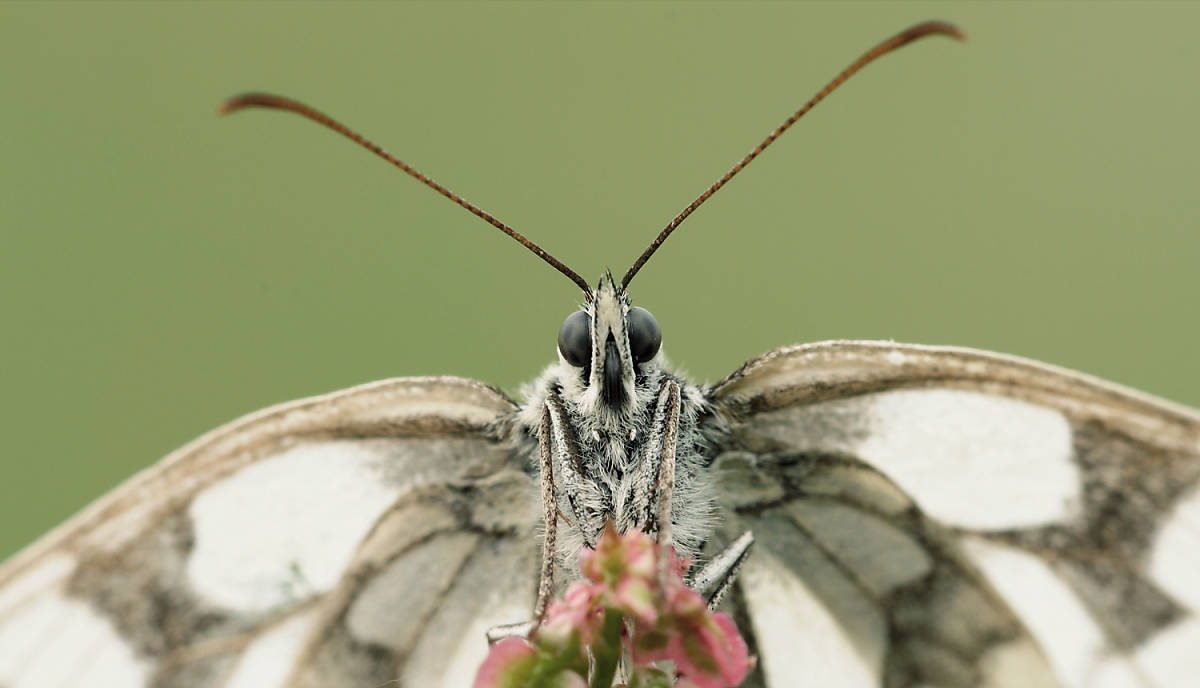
1150, 482, 1200, 612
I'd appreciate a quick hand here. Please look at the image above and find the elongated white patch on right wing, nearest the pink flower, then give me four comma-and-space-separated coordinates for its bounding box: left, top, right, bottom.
740, 550, 884, 688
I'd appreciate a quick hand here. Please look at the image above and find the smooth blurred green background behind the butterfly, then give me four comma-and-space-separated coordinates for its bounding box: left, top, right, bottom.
0, 2, 1200, 557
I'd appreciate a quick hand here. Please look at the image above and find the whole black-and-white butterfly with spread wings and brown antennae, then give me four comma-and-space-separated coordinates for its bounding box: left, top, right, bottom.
0, 23, 1200, 688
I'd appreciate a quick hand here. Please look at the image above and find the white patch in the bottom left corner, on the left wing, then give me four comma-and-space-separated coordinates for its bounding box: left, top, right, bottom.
0, 594, 150, 688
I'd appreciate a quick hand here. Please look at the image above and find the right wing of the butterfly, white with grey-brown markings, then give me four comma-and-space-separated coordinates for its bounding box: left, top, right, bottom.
712, 342, 1200, 687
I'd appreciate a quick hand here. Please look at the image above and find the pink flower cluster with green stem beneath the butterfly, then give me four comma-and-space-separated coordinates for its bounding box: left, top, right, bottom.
474, 527, 751, 688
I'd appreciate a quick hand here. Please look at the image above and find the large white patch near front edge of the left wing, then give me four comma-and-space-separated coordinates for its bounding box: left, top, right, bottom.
187, 441, 400, 612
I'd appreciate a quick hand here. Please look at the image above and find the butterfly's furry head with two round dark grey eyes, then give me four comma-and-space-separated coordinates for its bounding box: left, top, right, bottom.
558, 273, 662, 413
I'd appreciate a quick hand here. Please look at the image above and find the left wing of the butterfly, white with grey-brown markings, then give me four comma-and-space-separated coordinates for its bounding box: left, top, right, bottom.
0, 377, 539, 688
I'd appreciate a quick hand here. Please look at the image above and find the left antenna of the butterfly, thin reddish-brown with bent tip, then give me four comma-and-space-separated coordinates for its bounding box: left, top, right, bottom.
217, 94, 592, 295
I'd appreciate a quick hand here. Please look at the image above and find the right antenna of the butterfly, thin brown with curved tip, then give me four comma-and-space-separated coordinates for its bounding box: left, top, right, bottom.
620, 22, 966, 289
